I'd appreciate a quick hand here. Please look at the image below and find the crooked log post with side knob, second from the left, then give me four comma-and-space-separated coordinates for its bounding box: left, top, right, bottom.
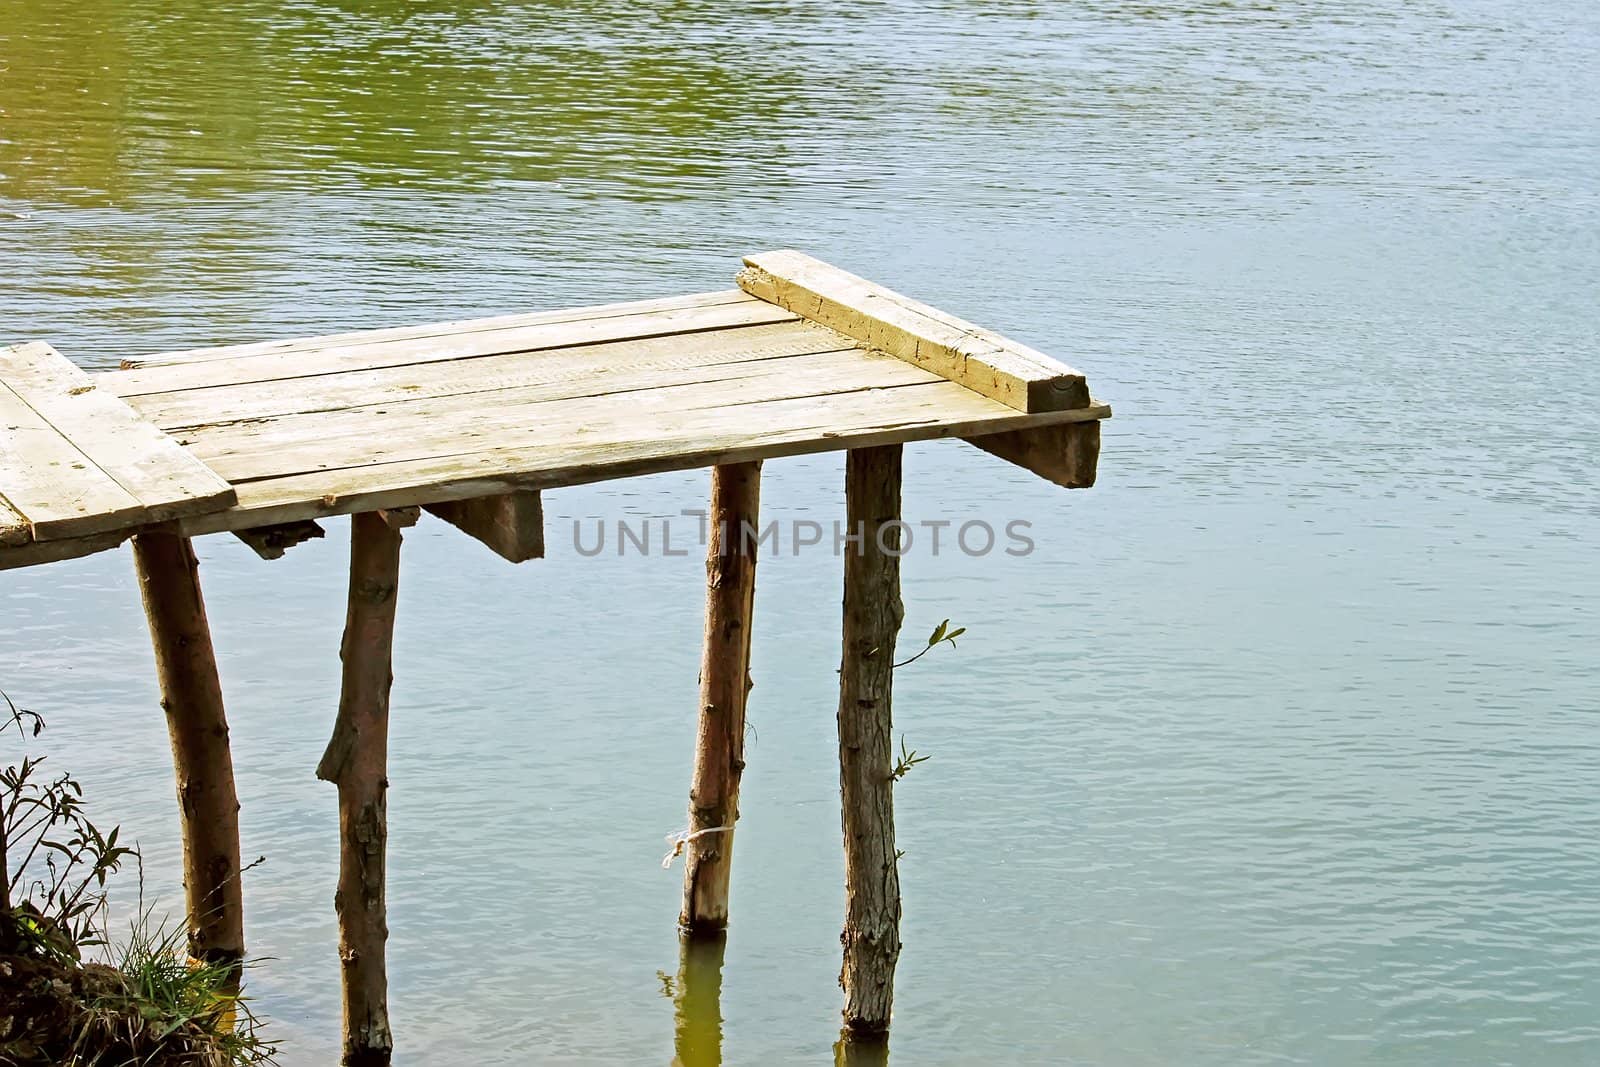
317, 512, 400, 1067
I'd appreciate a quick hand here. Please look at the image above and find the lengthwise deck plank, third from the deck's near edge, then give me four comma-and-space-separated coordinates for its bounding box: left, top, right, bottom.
128, 320, 854, 434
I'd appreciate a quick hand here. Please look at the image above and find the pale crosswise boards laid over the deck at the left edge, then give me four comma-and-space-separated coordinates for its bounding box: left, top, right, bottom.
0, 342, 235, 541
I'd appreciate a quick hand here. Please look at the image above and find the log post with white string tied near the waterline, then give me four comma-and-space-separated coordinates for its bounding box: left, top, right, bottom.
678, 461, 762, 937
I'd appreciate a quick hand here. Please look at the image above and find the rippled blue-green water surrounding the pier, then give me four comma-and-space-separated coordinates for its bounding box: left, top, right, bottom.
0, 0, 1600, 1067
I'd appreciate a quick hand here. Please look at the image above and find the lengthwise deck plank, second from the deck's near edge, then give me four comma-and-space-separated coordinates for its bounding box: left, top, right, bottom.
181, 349, 908, 482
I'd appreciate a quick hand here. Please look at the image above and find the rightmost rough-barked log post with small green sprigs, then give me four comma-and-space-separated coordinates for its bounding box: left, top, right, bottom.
838, 445, 904, 1033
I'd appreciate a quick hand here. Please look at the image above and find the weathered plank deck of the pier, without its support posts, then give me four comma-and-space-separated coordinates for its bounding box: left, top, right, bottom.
0, 253, 1109, 568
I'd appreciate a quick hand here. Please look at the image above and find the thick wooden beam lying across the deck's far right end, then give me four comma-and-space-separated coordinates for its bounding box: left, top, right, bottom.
739, 251, 1090, 411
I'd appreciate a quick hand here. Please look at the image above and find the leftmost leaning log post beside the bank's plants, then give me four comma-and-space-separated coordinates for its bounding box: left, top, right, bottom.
133, 531, 245, 966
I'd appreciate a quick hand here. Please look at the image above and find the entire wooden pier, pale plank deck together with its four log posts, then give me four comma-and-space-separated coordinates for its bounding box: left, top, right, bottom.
0, 251, 1110, 1064
